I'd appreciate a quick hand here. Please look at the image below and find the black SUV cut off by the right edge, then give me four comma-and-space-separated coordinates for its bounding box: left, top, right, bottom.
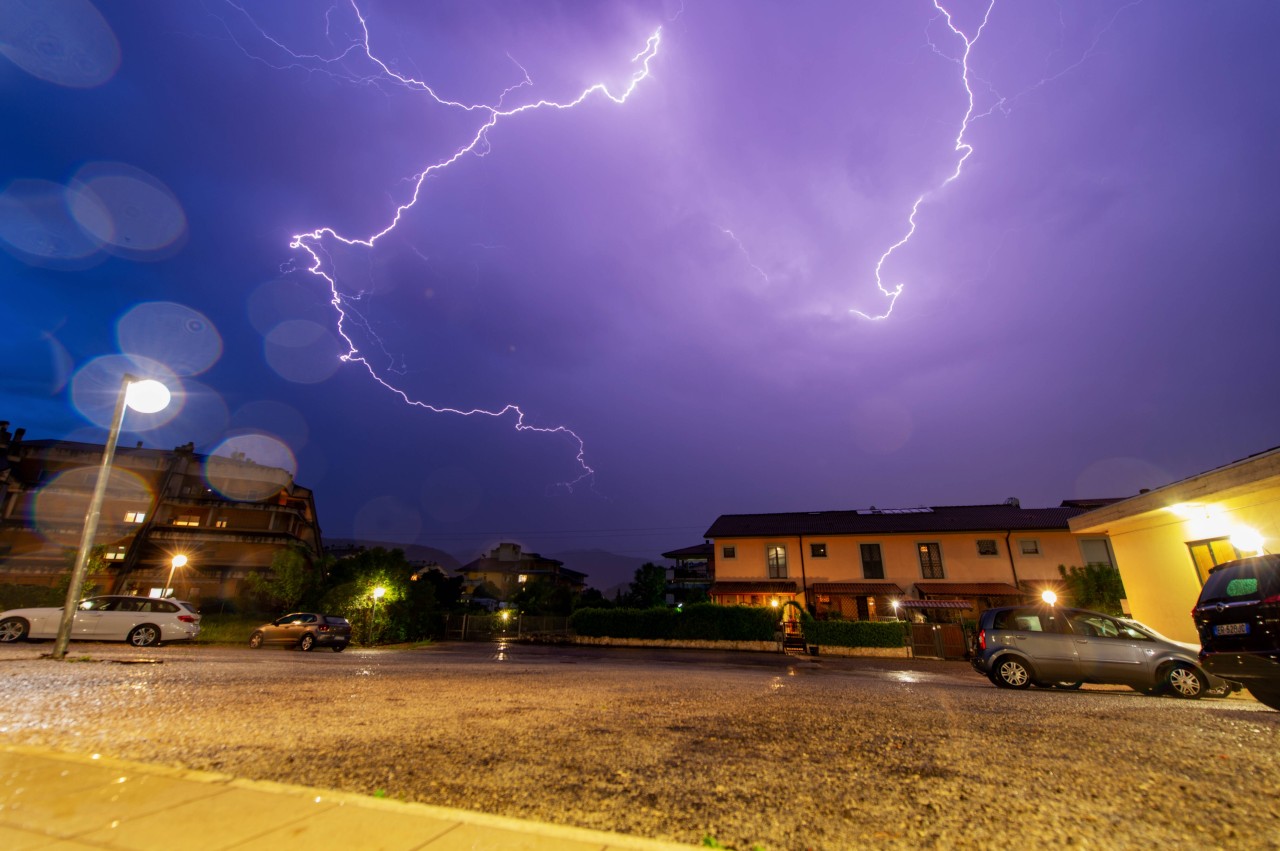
1192, 555, 1280, 709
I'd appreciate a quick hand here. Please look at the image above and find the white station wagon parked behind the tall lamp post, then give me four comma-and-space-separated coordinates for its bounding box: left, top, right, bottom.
0, 595, 200, 648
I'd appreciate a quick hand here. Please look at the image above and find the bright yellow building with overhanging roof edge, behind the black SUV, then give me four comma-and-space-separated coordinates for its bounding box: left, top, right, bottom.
1070, 447, 1280, 644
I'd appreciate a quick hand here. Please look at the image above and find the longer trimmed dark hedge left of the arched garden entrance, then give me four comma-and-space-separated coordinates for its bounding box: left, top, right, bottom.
568, 603, 778, 641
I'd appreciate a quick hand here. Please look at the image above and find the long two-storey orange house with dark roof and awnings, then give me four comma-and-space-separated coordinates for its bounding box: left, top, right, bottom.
705, 499, 1111, 621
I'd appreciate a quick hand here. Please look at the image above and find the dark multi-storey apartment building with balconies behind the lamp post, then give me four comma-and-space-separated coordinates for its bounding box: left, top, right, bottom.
0, 422, 321, 603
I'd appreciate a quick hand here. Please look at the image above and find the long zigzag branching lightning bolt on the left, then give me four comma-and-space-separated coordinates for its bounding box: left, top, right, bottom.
229, 0, 662, 490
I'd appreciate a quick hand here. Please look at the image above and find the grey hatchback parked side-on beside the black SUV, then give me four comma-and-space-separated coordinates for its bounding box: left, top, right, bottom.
970, 605, 1231, 699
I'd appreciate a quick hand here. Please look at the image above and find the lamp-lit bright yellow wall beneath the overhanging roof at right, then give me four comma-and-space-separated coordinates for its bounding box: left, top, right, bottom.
1073, 479, 1280, 644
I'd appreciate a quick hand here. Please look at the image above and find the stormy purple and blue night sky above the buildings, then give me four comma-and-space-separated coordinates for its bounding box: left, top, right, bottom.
0, 0, 1280, 558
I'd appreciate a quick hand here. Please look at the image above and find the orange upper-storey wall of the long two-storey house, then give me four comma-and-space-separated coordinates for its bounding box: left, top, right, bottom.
714, 530, 1097, 596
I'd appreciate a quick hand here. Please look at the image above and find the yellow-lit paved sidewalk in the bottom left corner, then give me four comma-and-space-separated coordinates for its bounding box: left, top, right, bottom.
0, 747, 692, 851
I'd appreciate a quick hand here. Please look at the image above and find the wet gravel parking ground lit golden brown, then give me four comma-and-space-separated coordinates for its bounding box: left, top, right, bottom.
0, 644, 1280, 851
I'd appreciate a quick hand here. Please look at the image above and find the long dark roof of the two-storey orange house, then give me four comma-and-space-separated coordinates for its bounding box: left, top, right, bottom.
705, 504, 1084, 537
